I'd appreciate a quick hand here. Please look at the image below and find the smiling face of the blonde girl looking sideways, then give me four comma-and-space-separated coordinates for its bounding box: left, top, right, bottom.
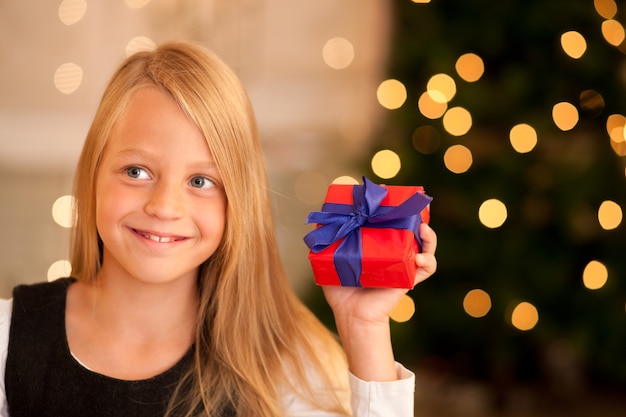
96, 87, 226, 283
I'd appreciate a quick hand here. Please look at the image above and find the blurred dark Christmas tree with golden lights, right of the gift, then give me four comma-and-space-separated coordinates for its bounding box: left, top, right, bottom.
370, 0, 626, 404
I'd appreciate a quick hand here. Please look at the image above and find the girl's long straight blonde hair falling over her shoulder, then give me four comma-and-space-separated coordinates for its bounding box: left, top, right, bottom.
71, 42, 348, 417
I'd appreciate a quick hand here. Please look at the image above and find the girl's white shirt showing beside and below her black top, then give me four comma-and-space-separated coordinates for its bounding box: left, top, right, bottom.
0, 299, 415, 417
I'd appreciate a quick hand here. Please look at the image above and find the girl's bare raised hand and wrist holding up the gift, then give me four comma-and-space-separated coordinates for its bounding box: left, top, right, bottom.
323, 223, 437, 381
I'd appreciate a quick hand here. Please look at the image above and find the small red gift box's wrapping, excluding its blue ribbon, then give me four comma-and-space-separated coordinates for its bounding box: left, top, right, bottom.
305, 179, 431, 288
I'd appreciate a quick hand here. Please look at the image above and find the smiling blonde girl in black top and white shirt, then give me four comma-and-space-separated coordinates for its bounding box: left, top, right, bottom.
0, 43, 436, 417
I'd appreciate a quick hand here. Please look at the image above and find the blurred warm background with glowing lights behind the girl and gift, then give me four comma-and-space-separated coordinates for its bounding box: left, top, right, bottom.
0, 0, 626, 417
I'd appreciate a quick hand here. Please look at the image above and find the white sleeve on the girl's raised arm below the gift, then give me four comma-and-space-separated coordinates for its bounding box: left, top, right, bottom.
283, 363, 415, 417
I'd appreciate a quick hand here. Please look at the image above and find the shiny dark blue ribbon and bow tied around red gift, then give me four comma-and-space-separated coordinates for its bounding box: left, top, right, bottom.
304, 177, 432, 287
